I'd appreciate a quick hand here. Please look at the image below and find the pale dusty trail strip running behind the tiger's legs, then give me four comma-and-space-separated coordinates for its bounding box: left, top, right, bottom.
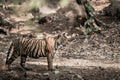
27, 58, 120, 69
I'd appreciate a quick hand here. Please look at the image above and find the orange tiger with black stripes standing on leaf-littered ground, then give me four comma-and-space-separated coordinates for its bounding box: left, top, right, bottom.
5, 34, 68, 71
